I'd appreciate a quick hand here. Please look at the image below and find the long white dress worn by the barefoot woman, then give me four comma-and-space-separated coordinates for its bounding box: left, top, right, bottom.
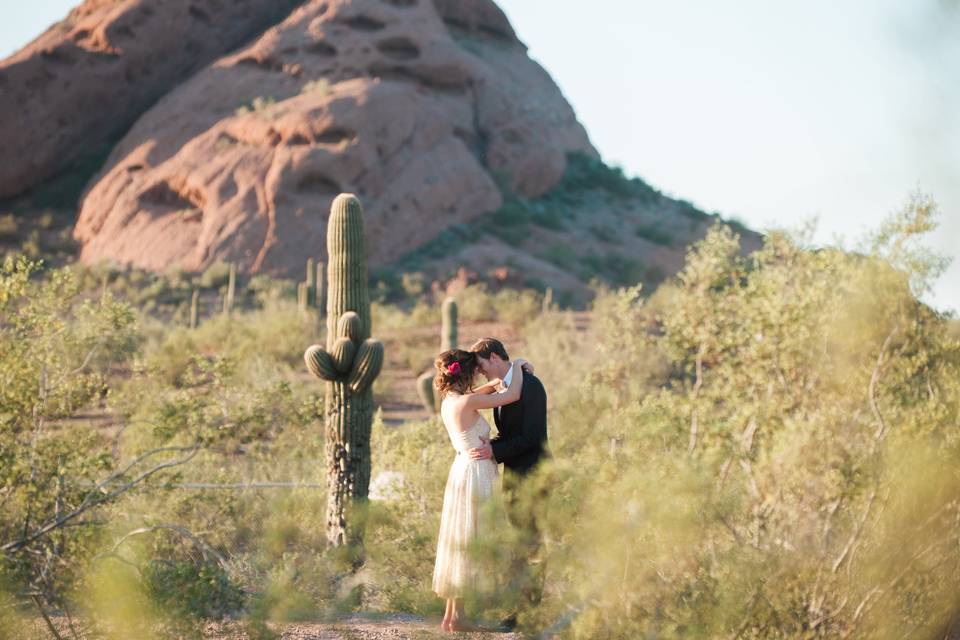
433, 408, 497, 598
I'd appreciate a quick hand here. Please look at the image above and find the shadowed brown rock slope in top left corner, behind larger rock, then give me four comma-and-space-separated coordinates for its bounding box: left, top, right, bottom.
0, 0, 297, 198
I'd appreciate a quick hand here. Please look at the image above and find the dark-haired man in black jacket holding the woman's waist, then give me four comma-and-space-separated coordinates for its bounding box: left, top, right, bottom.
470, 338, 547, 626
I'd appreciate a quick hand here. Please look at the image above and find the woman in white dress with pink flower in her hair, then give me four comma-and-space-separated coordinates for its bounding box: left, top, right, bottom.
433, 349, 524, 631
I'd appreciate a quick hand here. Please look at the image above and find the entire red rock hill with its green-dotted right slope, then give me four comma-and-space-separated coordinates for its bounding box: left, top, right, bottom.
0, 0, 757, 302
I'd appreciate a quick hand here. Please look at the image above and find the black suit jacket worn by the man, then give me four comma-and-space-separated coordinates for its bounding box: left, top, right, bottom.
490, 371, 547, 475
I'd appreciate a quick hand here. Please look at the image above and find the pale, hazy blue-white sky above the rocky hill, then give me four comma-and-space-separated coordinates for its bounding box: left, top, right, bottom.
0, 0, 960, 312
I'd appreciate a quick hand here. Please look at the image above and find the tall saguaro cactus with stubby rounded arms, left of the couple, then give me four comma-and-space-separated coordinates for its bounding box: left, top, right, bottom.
303, 194, 383, 545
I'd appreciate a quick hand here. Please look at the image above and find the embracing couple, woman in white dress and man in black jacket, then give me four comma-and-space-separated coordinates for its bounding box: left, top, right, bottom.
433, 338, 547, 631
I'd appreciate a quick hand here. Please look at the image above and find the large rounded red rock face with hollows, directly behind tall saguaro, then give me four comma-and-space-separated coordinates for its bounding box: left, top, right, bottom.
75, 0, 596, 275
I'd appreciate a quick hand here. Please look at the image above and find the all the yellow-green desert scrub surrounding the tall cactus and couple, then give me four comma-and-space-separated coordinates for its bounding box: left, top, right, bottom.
0, 196, 960, 639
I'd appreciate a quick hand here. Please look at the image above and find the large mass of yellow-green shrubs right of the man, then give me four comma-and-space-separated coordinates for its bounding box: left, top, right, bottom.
502, 201, 960, 638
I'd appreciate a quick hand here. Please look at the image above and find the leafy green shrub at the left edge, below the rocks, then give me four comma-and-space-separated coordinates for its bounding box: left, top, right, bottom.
0, 257, 140, 601
